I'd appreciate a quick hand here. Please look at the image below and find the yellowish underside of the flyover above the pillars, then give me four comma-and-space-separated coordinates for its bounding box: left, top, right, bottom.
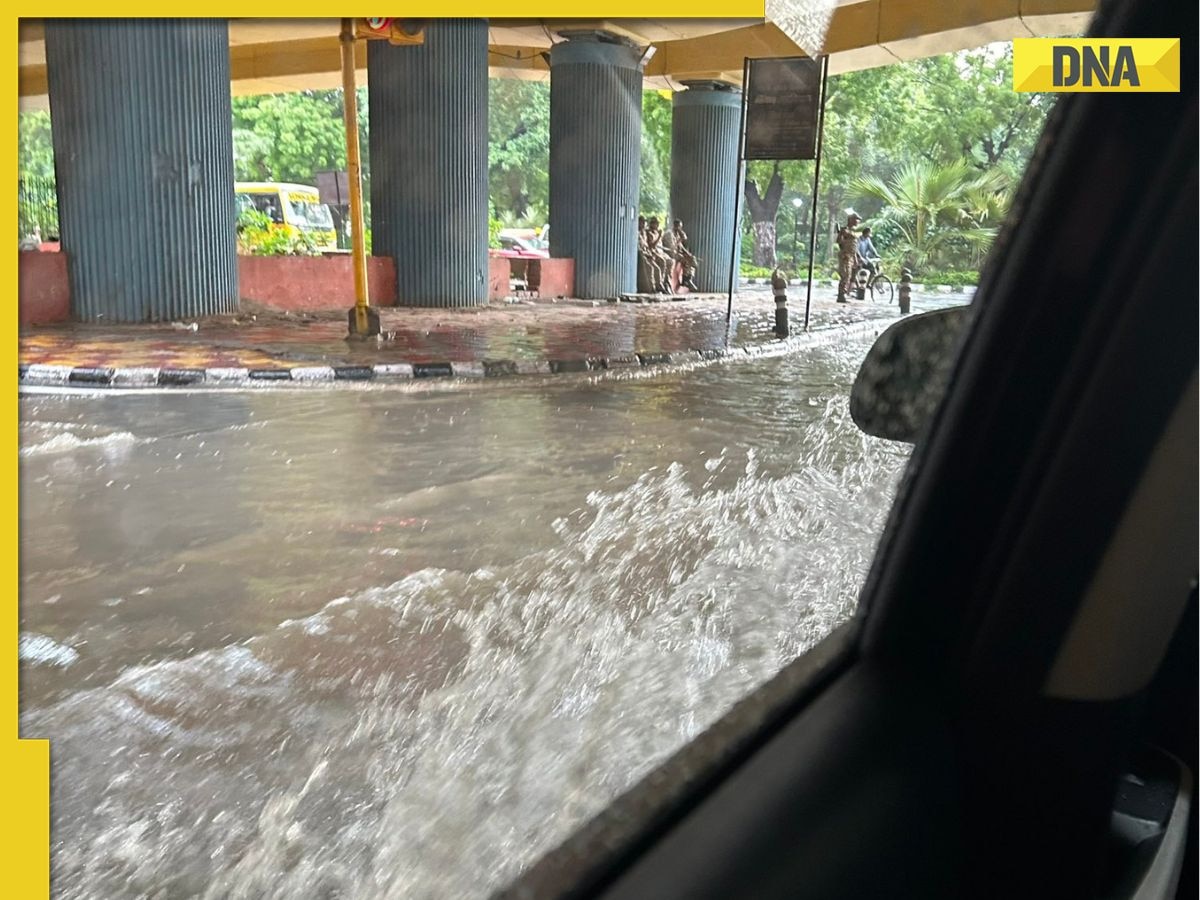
18, 0, 1096, 109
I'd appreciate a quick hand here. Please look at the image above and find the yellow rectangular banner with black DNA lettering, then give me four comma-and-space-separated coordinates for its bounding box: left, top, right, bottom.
1013, 37, 1180, 94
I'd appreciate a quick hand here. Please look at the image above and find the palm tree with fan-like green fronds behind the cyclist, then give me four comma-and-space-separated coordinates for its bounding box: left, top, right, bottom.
853, 160, 1008, 269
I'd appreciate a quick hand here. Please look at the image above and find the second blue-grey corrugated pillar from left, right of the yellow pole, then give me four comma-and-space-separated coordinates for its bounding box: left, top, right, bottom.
367, 19, 487, 307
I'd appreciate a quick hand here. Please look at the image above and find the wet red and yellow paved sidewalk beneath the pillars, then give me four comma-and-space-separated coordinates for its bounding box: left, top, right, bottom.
19, 288, 965, 370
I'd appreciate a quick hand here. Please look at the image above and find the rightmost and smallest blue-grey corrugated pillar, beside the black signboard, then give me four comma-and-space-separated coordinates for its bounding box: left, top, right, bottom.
671, 82, 742, 292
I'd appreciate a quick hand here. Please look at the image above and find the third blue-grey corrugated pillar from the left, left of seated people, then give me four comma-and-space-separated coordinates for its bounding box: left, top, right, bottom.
550, 36, 642, 299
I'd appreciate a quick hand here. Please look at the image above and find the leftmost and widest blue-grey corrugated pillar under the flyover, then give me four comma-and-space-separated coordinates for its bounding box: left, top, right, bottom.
46, 19, 238, 322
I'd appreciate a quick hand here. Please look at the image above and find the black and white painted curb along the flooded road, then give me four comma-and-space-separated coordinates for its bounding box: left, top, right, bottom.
18, 317, 898, 388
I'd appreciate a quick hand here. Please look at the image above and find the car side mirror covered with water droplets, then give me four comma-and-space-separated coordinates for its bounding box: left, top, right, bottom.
850, 306, 971, 444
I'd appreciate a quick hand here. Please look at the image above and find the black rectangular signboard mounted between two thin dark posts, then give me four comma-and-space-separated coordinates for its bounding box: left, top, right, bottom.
743, 56, 821, 160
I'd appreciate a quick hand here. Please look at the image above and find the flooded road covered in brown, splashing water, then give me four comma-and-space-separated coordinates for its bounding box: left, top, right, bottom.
20, 341, 907, 898
